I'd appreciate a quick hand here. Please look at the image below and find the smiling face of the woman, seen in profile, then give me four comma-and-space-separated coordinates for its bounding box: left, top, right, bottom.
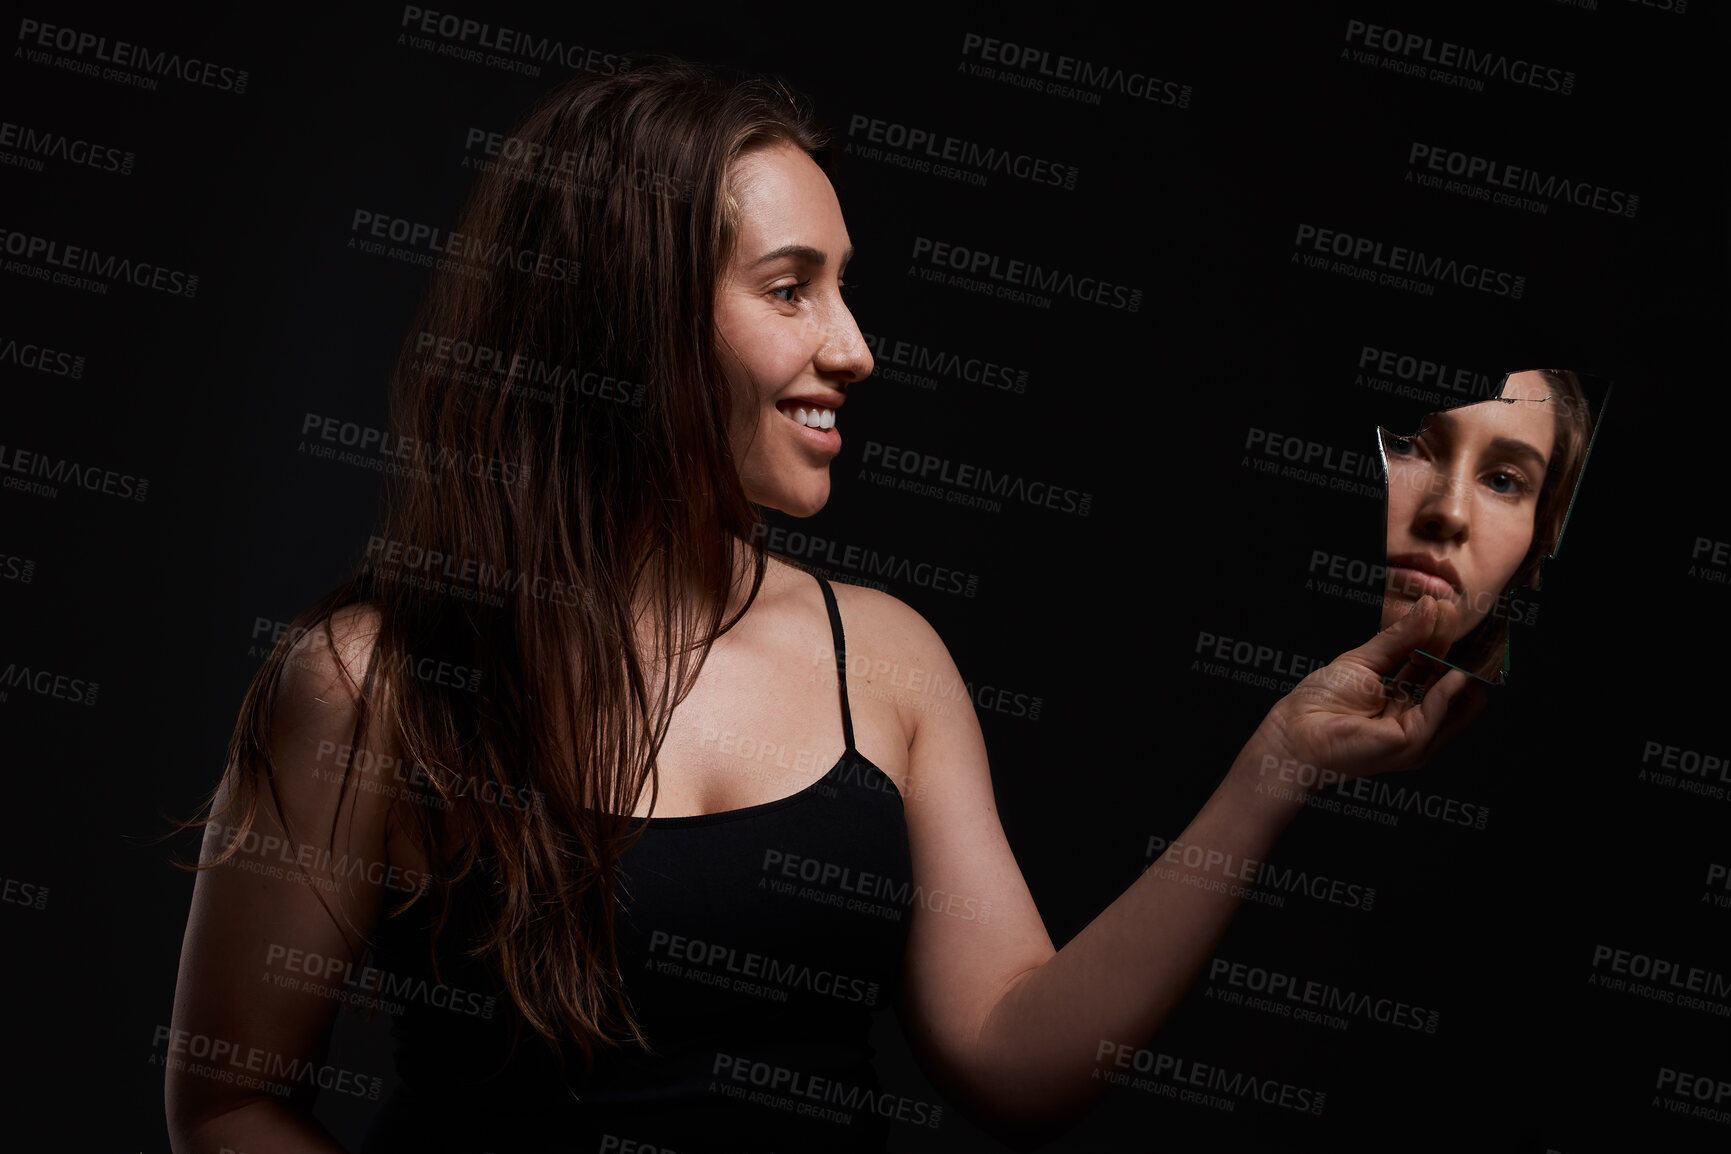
715, 144, 872, 517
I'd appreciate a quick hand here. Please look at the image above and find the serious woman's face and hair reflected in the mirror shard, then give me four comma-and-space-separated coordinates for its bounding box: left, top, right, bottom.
1378, 369, 1593, 683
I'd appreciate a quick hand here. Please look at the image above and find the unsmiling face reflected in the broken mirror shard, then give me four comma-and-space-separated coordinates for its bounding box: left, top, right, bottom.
1383, 372, 1556, 645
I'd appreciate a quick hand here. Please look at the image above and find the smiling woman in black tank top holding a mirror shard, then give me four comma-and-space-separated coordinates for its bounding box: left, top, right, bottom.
166, 62, 1466, 1154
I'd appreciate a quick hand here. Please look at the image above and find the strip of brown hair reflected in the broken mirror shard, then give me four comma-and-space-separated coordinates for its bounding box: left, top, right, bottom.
1449, 369, 1593, 682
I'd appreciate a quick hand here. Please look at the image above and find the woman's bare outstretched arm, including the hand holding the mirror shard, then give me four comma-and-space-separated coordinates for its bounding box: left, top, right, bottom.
879, 599, 1478, 1135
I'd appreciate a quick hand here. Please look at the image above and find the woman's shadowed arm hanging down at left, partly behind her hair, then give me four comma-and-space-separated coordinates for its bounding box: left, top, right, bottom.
164, 611, 403, 1154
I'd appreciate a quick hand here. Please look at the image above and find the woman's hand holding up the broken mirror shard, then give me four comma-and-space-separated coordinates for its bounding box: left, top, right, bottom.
1232, 595, 1485, 792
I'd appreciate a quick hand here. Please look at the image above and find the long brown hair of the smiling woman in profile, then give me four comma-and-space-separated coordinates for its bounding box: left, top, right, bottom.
187, 59, 824, 1059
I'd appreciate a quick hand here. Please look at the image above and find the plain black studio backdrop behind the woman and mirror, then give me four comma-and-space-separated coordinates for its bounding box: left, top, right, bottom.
0, 0, 1731, 1154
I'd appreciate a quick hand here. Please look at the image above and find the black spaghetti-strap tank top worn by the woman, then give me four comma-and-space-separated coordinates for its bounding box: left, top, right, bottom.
364, 578, 913, 1154
